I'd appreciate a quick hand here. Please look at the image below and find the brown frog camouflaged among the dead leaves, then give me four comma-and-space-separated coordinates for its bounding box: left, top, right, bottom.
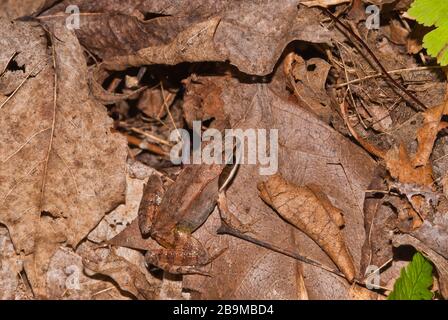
138, 164, 225, 275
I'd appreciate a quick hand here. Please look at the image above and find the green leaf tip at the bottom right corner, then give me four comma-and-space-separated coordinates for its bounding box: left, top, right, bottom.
387, 252, 433, 300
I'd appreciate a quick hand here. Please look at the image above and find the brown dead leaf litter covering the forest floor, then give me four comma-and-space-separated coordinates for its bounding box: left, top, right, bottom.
0, 0, 448, 299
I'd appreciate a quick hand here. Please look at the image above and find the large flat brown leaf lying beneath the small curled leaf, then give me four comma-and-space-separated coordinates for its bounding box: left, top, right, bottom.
184, 77, 374, 299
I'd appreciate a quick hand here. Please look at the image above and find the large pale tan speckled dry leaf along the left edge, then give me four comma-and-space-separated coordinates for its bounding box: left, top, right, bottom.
0, 20, 127, 296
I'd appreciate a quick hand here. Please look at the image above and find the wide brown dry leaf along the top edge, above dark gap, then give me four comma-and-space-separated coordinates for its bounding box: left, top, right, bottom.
43, 0, 334, 75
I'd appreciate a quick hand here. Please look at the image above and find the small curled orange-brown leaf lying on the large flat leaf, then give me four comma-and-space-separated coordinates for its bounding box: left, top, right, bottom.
258, 174, 355, 282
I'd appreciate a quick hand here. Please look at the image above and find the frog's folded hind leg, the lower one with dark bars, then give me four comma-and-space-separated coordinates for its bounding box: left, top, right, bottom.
145, 230, 220, 275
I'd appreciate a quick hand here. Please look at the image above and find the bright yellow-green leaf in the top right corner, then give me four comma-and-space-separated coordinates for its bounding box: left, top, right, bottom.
408, 0, 448, 66
